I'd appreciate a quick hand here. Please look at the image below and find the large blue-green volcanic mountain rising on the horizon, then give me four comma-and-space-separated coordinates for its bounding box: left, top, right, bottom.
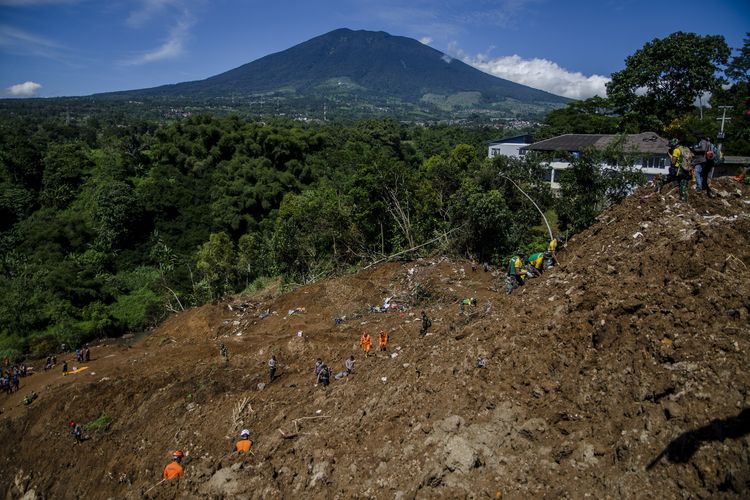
94, 29, 569, 120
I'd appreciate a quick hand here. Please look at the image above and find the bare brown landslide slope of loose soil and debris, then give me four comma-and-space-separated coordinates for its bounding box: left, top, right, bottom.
0, 179, 750, 498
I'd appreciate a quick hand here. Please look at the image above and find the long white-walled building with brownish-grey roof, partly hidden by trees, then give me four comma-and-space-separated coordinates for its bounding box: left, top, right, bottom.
519, 132, 669, 189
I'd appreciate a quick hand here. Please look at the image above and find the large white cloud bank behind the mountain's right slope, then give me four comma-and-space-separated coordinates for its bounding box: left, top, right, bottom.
462, 49, 610, 99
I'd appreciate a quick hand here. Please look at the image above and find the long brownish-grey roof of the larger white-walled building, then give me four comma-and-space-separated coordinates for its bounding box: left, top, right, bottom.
524, 132, 669, 155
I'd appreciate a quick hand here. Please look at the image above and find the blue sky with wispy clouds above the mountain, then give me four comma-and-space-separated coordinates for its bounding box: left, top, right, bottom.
0, 0, 750, 98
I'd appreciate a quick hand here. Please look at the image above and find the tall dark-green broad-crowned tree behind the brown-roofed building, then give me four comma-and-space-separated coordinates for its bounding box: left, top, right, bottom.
607, 32, 730, 129
